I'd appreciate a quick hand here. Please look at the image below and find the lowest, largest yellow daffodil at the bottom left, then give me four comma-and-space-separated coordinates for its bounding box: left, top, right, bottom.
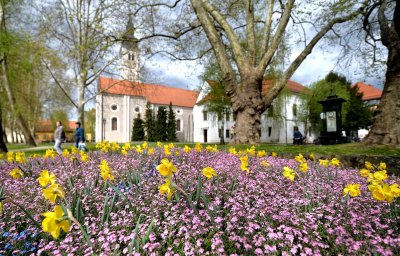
42, 205, 70, 239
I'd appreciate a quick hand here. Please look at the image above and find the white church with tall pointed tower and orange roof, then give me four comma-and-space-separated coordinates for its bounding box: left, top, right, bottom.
95, 19, 198, 143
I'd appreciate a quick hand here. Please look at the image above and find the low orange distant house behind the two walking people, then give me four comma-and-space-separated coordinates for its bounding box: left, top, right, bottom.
35, 120, 76, 143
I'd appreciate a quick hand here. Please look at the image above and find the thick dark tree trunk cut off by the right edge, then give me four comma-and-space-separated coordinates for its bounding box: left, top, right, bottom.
364, 0, 400, 145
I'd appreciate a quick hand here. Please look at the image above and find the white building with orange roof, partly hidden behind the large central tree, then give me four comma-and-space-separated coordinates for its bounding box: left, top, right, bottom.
193, 80, 316, 143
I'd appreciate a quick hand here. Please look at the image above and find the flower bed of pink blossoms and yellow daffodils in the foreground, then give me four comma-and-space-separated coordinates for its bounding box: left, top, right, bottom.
0, 143, 400, 255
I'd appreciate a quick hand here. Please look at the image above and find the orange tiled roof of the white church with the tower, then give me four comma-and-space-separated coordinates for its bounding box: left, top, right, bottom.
99, 77, 199, 108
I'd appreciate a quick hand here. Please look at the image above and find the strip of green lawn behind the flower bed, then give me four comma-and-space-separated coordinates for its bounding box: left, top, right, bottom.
7, 142, 400, 157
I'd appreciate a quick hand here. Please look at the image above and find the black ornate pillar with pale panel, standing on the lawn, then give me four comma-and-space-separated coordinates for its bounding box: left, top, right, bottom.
318, 91, 346, 144
